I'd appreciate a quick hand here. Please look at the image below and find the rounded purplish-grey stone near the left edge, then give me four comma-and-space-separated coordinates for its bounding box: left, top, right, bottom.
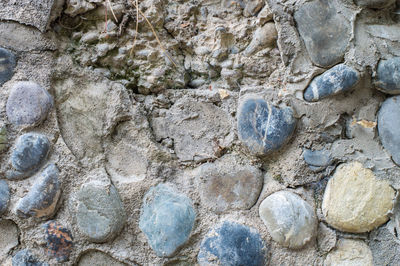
6, 81, 53, 126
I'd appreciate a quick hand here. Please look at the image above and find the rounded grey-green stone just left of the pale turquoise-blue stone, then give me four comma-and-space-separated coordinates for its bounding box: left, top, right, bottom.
75, 181, 126, 243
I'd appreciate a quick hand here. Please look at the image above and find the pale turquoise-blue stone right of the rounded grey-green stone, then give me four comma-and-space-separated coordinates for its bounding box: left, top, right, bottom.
139, 184, 196, 257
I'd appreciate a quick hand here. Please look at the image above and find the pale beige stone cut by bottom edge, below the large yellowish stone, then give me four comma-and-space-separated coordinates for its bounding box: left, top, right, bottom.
324, 239, 373, 266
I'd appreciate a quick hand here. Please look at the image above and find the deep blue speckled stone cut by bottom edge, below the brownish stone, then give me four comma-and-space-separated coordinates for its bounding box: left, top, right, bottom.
197, 221, 267, 266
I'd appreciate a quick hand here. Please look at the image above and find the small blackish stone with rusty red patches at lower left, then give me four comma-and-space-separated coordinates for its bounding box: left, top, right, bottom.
43, 221, 73, 262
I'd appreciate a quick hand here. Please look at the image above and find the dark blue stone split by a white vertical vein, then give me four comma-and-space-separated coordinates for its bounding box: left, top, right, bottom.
237, 98, 296, 155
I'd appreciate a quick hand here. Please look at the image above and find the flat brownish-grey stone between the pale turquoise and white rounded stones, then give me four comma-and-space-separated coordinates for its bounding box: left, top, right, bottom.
197, 156, 263, 213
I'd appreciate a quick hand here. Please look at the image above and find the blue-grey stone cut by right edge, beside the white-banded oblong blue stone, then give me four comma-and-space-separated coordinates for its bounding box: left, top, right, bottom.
375, 57, 400, 94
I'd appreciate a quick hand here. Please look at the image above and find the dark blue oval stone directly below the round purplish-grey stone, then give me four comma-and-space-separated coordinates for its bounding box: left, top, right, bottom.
6, 133, 50, 179
